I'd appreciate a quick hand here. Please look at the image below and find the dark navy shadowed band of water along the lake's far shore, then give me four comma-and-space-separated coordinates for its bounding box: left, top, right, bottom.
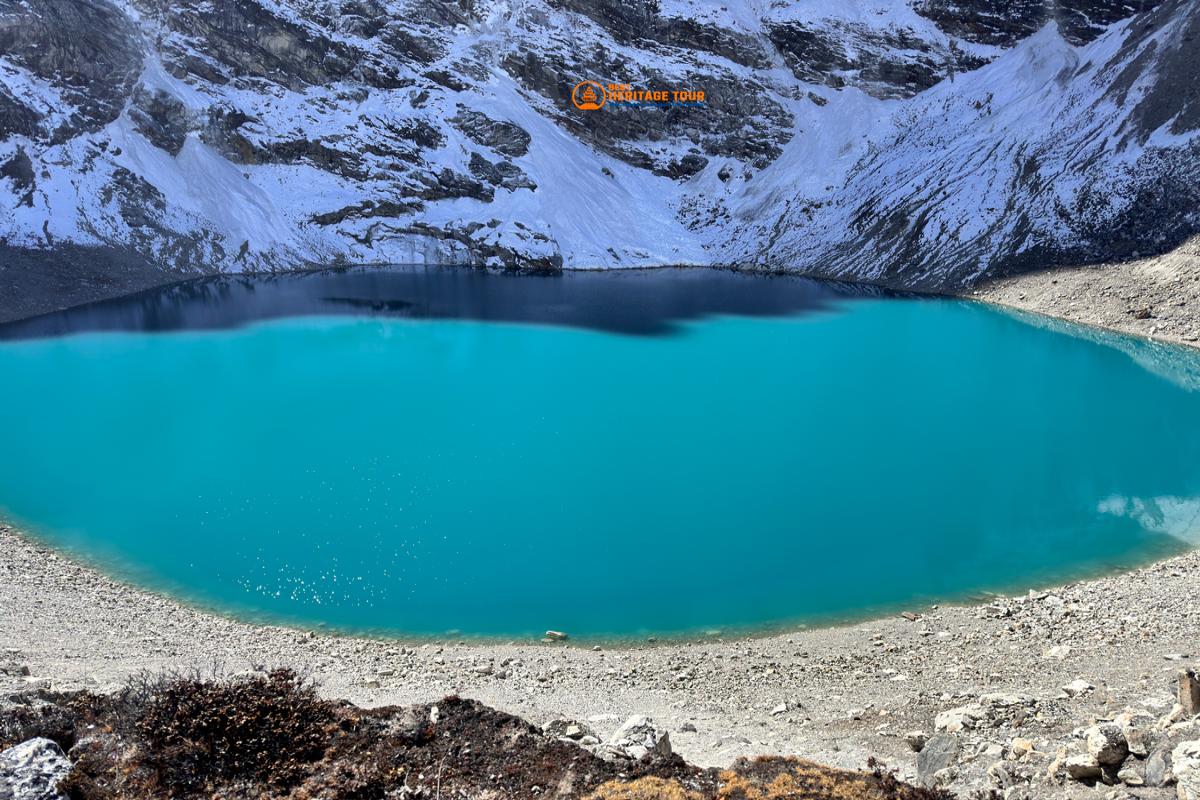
0, 266, 882, 339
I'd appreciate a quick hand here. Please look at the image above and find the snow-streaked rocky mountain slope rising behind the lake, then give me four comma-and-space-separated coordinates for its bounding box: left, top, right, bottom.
0, 0, 1200, 288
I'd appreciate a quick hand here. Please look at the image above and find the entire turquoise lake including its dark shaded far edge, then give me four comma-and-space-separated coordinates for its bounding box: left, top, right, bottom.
0, 270, 1200, 637
